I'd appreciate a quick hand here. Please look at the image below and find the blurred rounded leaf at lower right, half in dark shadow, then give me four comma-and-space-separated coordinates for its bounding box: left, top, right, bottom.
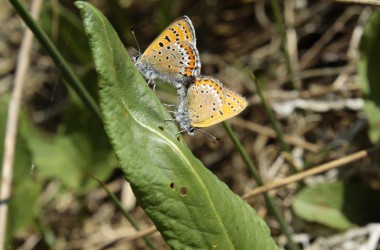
293, 182, 380, 230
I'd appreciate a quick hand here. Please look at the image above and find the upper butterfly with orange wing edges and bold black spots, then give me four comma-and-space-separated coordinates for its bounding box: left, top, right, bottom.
132, 16, 201, 94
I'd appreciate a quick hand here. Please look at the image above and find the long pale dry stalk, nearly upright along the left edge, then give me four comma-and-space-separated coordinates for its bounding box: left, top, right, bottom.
0, 0, 42, 250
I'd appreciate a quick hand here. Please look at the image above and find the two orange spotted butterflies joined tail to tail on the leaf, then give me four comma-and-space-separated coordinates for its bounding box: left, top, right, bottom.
133, 16, 248, 135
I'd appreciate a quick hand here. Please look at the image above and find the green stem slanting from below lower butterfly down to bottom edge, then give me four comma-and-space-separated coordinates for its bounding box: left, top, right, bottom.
223, 122, 299, 250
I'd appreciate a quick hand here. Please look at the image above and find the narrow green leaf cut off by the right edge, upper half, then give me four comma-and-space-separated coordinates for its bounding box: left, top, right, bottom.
358, 11, 380, 144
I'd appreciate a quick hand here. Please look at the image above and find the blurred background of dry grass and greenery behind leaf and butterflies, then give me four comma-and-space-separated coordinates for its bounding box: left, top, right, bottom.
0, 0, 380, 249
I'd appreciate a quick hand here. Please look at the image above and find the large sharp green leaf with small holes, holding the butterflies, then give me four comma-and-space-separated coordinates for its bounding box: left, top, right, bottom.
76, 2, 277, 249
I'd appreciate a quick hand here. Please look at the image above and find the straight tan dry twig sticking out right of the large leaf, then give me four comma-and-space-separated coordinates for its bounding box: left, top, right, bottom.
242, 148, 378, 199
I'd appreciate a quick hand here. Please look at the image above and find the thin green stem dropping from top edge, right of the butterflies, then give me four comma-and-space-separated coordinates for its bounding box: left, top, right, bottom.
270, 0, 300, 89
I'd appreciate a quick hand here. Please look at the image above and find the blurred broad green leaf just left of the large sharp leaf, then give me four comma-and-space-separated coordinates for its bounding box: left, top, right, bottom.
27, 101, 117, 194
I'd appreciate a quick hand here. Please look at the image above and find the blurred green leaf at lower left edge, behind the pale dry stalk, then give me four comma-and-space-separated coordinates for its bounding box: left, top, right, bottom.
0, 94, 41, 242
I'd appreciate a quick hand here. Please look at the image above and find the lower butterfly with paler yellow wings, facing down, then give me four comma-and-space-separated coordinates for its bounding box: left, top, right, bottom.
175, 76, 248, 135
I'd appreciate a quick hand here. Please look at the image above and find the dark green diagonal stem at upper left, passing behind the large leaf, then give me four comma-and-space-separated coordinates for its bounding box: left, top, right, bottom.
9, 0, 101, 121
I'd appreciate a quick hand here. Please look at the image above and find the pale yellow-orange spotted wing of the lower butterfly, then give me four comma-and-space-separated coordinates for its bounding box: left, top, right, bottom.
188, 78, 248, 128
